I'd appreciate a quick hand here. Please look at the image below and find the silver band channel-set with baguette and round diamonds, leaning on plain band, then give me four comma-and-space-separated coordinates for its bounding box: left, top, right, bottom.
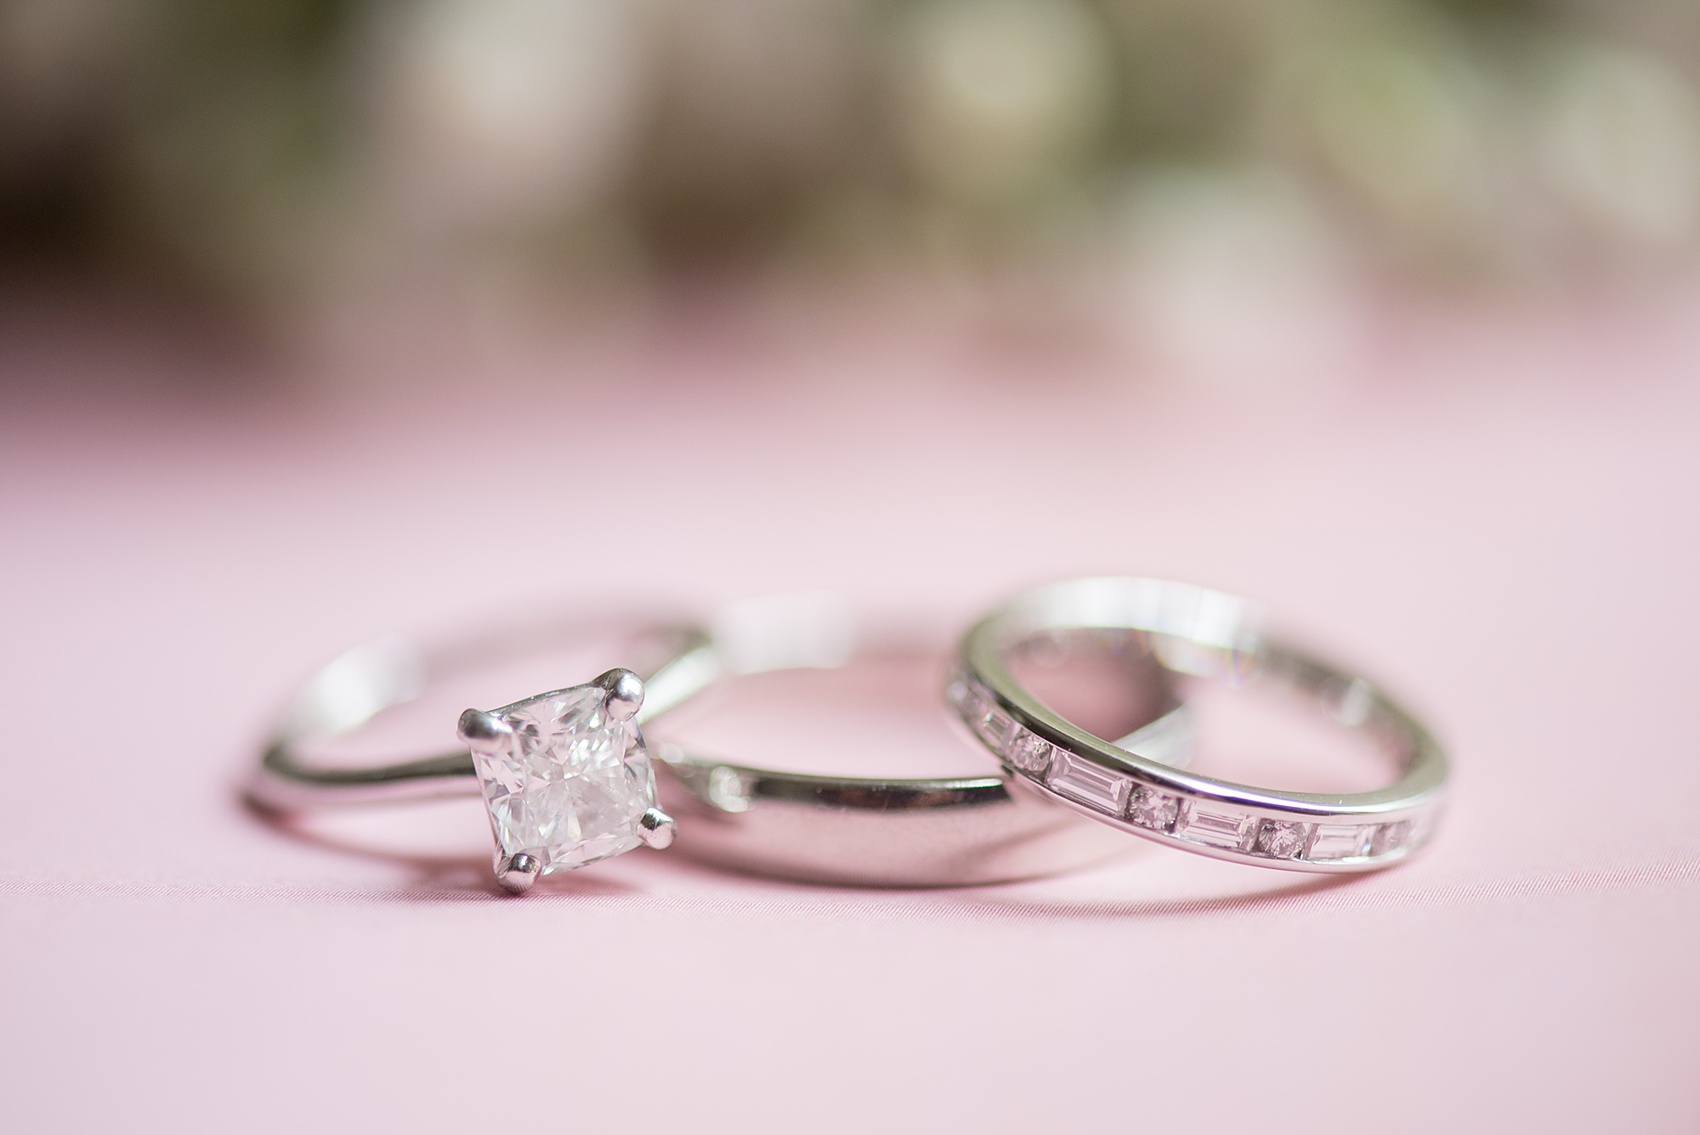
949, 578, 1447, 872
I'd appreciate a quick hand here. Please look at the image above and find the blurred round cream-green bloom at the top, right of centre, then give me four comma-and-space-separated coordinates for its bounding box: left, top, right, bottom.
896, 0, 1115, 200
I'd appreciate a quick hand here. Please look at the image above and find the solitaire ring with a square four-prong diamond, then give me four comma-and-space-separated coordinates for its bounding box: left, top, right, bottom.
248, 629, 717, 894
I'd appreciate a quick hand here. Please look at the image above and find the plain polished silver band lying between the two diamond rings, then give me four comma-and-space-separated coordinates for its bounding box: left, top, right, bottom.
651, 593, 1190, 887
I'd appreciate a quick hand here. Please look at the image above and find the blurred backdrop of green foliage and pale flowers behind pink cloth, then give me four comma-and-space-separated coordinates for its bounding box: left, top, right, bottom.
0, 0, 1700, 319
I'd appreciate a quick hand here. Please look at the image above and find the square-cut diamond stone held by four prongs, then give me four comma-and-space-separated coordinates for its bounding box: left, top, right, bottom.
473, 685, 655, 875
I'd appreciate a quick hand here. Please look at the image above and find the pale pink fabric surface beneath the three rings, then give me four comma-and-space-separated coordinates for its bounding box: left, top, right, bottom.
0, 299, 1700, 1132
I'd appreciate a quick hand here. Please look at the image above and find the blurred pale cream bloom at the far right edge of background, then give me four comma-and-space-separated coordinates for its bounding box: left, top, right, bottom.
1537, 46, 1700, 251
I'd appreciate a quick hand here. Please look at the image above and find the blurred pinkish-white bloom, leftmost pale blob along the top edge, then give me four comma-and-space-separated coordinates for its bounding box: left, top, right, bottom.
360, 0, 649, 231
